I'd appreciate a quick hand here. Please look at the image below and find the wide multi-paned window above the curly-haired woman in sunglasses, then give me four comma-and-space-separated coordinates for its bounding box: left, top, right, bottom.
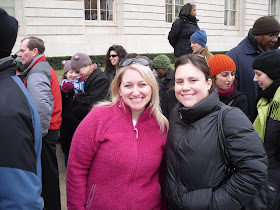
85, 0, 113, 21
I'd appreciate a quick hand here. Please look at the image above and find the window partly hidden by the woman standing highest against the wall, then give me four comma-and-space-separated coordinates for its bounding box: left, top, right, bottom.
165, 0, 184, 23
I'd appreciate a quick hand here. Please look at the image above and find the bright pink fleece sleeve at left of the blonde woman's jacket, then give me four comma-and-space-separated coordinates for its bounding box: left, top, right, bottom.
66, 110, 99, 210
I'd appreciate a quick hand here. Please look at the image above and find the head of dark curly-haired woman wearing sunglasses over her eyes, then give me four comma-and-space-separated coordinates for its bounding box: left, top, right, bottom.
105, 45, 127, 84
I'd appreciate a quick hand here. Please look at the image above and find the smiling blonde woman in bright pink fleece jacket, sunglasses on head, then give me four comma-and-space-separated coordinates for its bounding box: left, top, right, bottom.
67, 58, 168, 210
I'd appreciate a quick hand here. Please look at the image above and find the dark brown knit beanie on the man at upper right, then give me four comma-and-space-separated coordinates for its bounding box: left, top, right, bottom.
252, 16, 280, 35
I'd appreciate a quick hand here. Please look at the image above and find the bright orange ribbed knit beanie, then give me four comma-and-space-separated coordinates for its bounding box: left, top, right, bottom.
208, 54, 236, 77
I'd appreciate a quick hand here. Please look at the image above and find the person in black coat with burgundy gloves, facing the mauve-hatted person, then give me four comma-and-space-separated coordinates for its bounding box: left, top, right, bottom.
59, 60, 84, 167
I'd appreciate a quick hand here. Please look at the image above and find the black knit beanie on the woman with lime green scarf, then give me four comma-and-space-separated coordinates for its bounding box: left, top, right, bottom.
252, 50, 280, 80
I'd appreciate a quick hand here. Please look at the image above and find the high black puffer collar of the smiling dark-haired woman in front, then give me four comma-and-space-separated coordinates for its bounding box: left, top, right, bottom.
178, 89, 220, 124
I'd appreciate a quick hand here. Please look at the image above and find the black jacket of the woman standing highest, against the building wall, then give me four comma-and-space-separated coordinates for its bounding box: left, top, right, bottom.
168, 15, 199, 58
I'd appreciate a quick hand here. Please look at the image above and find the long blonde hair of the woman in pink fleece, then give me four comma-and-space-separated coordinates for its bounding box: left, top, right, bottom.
94, 62, 169, 133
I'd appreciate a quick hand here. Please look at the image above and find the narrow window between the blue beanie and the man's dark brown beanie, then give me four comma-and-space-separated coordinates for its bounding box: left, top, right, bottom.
224, 0, 237, 26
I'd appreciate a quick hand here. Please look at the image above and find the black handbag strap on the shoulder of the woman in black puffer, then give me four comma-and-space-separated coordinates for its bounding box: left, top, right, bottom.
217, 106, 233, 167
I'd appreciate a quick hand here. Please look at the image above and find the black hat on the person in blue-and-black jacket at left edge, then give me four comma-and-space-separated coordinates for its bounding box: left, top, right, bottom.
0, 8, 18, 58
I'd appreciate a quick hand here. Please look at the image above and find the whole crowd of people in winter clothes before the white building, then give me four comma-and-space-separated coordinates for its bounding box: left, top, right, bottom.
0, 3, 280, 210
